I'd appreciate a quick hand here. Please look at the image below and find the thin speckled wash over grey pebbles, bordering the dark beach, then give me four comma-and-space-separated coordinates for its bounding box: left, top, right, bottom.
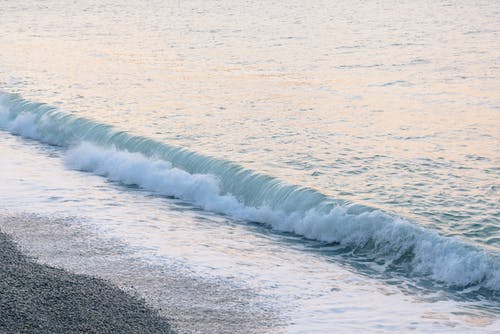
0, 214, 280, 334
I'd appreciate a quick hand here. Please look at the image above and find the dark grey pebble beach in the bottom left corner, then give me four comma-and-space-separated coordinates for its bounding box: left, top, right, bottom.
0, 231, 174, 333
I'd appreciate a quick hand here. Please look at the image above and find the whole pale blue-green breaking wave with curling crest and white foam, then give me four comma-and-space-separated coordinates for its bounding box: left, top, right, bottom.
0, 93, 500, 294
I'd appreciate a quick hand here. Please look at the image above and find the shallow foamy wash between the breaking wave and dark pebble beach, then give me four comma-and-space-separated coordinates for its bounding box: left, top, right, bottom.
0, 133, 498, 333
